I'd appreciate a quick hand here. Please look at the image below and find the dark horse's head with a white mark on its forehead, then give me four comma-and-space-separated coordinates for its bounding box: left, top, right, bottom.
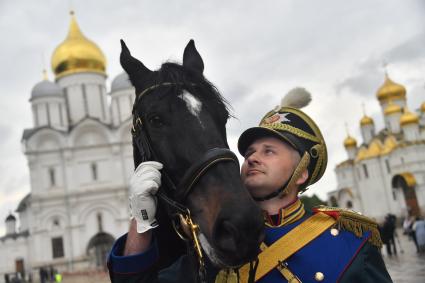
120, 40, 263, 266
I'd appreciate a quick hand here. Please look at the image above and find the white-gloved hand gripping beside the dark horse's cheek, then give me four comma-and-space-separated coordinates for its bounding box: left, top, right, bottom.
130, 161, 162, 233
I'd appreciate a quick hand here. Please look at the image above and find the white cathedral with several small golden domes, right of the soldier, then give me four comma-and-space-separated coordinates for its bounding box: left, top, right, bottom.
328, 74, 425, 222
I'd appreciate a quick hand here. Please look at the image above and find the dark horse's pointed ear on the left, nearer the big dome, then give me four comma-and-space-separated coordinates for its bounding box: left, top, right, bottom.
120, 39, 152, 89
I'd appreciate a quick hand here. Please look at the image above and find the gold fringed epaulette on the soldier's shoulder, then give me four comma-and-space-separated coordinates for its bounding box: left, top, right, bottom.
313, 205, 382, 248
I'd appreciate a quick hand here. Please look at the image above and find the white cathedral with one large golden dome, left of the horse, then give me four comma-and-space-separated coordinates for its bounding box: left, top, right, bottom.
0, 13, 134, 282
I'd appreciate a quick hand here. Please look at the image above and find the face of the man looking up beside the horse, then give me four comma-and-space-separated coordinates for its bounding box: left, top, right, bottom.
241, 137, 300, 197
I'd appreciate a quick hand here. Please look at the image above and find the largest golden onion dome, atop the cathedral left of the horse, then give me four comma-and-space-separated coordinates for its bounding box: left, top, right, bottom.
52, 11, 106, 78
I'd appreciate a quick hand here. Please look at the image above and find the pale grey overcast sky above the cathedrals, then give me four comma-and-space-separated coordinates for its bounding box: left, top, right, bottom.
0, 0, 425, 235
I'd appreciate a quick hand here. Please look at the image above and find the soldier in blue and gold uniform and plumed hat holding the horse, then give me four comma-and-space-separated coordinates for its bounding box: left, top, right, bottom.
108, 88, 392, 283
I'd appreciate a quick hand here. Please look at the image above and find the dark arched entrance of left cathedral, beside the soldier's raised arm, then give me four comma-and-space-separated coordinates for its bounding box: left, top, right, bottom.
87, 232, 114, 269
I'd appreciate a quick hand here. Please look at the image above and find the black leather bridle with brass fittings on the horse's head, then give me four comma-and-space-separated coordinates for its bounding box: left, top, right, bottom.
131, 82, 239, 282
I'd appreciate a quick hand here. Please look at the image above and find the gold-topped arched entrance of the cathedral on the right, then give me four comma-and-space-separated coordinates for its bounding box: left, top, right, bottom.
391, 173, 420, 216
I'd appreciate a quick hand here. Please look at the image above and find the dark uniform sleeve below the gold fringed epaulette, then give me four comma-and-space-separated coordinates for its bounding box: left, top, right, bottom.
339, 243, 393, 283
